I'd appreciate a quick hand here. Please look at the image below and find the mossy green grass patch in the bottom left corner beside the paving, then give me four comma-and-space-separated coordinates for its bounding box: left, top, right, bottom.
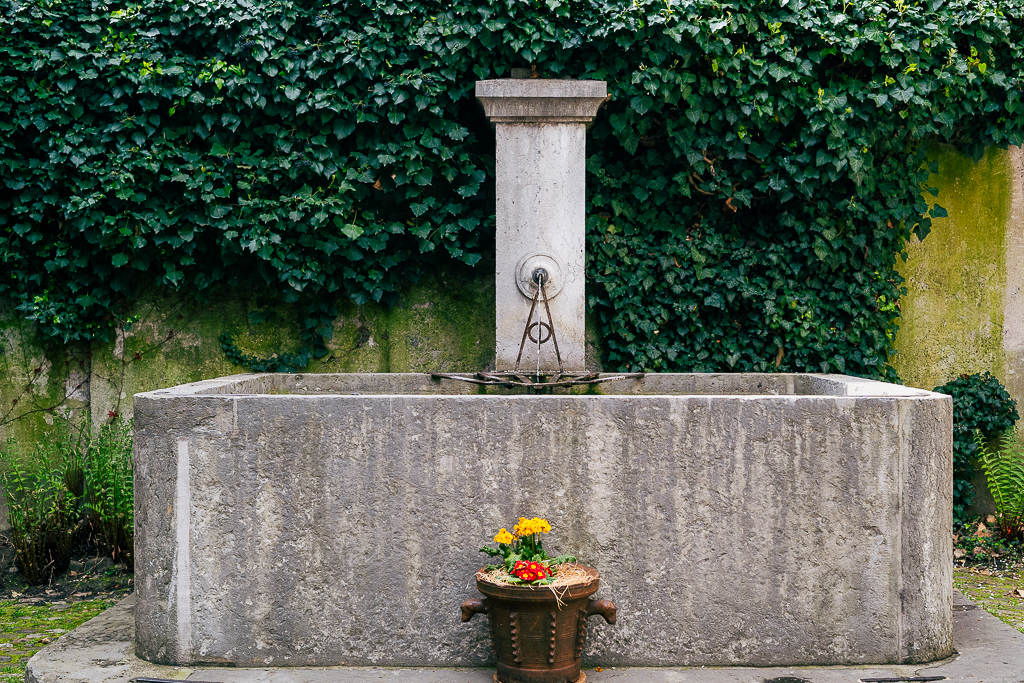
0, 599, 117, 681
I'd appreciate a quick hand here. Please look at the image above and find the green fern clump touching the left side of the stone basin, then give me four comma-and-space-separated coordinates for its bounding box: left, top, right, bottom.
84, 420, 135, 569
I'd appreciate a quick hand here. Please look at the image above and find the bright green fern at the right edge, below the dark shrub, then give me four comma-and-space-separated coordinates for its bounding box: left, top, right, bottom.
975, 427, 1024, 541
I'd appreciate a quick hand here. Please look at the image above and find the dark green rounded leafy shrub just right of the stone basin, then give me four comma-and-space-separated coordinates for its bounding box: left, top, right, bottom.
935, 372, 1020, 520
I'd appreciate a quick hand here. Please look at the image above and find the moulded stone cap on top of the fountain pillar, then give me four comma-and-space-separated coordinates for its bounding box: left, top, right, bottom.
476, 78, 608, 124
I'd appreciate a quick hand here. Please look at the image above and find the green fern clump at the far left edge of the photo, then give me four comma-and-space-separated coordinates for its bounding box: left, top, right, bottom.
0, 430, 81, 584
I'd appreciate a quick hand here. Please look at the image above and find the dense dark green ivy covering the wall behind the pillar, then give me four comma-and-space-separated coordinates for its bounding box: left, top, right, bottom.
0, 0, 1024, 379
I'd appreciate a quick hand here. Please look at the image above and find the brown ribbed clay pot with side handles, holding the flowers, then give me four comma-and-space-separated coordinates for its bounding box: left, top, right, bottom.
462, 566, 615, 683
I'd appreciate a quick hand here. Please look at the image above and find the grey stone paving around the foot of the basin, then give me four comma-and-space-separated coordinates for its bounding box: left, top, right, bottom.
25, 593, 1024, 683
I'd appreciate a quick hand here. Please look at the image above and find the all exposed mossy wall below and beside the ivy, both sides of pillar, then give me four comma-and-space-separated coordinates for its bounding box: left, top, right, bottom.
0, 146, 1024, 442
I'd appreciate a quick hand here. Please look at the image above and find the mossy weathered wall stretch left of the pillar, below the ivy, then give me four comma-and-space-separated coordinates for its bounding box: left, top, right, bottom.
0, 263, 499, 447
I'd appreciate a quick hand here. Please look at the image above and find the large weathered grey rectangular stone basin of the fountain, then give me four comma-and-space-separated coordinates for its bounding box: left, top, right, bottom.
135, 374, 952, 667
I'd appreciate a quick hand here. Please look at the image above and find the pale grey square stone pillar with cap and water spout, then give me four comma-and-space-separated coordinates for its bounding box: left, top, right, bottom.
476, 79, 607, 371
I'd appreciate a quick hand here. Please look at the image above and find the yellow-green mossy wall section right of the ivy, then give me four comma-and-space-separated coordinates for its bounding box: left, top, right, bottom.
893, 145, 1012, 389
